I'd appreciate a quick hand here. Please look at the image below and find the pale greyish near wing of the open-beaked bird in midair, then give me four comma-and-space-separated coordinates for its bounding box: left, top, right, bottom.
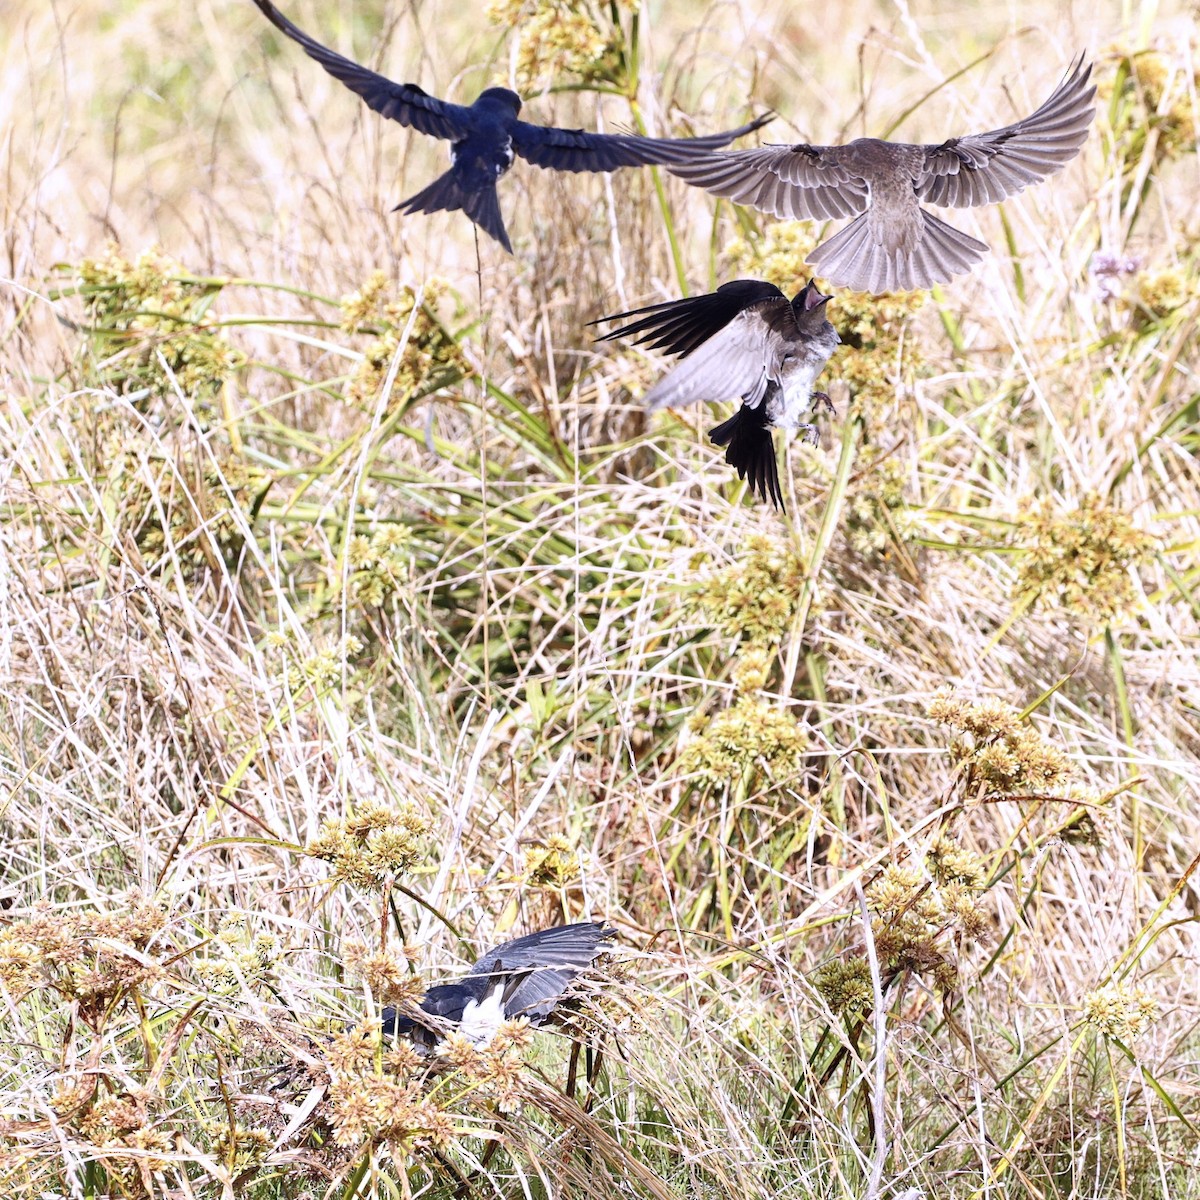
643, 296, 797, 412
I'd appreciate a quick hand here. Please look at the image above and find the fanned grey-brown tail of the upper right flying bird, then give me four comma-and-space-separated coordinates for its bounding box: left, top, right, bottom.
808, 209, 988, 295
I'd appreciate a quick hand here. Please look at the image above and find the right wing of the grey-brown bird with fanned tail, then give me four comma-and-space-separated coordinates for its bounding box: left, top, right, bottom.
917, 55, 1096, 208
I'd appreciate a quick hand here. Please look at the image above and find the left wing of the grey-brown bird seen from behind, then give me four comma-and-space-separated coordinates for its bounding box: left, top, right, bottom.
667, 142, 870, 221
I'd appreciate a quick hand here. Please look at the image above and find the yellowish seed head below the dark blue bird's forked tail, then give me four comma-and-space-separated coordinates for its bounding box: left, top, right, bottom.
341, 271, 469, 407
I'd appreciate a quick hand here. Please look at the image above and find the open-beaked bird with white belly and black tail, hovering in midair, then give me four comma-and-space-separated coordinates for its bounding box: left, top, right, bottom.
594, 280, 841, 509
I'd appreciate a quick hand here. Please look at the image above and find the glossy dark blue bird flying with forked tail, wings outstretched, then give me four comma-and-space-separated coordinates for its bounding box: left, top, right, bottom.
254, 0, 774, 254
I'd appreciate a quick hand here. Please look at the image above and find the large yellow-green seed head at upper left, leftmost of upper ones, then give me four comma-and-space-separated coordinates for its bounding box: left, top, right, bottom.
78, 246, 245, 419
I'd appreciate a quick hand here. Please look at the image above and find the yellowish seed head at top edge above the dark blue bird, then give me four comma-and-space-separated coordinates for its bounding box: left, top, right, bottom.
485, 0, 640, 91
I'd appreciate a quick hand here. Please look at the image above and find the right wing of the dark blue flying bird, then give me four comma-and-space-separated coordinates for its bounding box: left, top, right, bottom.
511, 112, 774, 170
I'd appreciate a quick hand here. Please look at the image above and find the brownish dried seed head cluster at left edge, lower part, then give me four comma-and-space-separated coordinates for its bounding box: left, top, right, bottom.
0, 893, 167, 1027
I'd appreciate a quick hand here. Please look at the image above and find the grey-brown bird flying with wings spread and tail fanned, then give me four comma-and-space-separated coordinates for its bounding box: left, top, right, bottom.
667, 55, 1096, 293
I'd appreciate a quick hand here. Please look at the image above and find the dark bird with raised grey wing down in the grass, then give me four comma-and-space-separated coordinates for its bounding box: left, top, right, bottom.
383, 920, 616, 1046
